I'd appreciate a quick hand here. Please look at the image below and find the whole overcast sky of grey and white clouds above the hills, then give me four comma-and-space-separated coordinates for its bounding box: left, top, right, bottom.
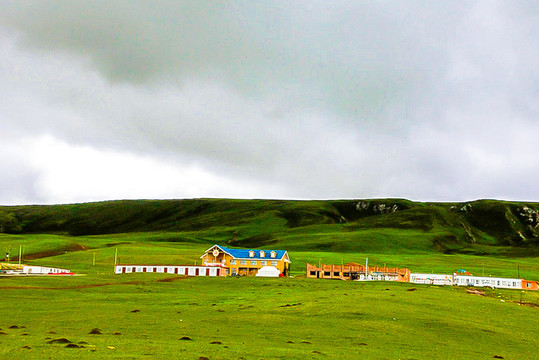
0, 0, 539, 205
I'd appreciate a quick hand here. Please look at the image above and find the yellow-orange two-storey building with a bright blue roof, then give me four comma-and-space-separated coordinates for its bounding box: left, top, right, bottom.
200, 245, 290, 276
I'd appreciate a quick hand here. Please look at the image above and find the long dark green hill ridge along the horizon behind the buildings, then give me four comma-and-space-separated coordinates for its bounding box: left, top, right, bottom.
0, 199, 539, 253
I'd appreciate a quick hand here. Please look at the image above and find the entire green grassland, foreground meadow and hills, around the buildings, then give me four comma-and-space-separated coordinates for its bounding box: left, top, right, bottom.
0, 200, 539, 360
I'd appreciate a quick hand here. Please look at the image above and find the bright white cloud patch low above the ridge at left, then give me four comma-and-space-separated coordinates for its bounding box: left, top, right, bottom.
4, 136, 294, 203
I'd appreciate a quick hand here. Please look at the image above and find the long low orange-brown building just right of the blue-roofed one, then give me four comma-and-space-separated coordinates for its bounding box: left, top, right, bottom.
307, 263, 410, 282
